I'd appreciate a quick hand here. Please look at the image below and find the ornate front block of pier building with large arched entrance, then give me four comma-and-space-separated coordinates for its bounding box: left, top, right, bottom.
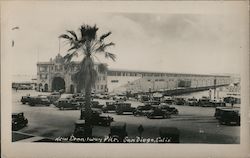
37, 54, 107, 93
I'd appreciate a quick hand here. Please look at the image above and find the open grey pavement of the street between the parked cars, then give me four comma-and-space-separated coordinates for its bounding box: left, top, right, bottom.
12, 90, 240, 144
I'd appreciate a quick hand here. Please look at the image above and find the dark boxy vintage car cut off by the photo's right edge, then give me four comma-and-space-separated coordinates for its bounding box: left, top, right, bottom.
218, 108, 240, 126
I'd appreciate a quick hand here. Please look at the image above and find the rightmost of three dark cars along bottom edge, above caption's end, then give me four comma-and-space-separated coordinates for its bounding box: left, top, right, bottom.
159, 127, 180, 143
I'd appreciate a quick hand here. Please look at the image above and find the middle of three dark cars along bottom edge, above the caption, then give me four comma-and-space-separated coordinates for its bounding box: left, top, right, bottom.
109, 122, 128, 143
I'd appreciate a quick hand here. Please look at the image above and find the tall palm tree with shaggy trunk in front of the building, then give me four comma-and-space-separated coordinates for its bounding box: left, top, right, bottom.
59, 25, 116, 135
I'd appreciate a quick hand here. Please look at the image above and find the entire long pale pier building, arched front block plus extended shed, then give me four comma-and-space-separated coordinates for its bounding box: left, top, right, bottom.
37, 54, 231, 93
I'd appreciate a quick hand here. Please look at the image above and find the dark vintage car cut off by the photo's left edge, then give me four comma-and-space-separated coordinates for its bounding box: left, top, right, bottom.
12, 112, 28, 131
